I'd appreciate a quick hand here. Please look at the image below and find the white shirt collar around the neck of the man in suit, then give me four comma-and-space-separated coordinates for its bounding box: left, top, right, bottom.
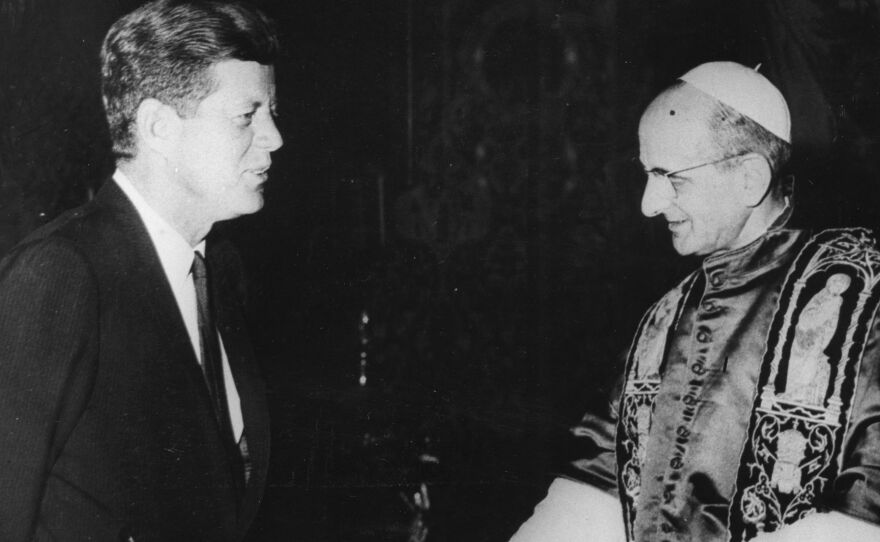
113, 169, 205, 285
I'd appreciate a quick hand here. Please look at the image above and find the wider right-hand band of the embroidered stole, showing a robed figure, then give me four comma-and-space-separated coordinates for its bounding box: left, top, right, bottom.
730, 230, 880, 541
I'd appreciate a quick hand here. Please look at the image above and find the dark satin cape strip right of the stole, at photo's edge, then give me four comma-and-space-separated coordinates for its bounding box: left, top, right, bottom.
830, 308, 880, 524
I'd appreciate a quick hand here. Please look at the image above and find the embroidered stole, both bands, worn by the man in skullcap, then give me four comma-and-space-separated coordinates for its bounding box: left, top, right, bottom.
617, 229, 880, 542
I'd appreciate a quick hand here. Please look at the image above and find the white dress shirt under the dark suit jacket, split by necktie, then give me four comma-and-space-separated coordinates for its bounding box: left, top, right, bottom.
113, 169, 244, 442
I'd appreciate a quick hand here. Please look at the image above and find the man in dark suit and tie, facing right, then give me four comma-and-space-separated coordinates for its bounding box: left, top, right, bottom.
0, 0, 282, 541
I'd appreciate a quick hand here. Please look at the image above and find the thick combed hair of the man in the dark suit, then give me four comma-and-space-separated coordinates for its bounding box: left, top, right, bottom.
101, 0, 279, 159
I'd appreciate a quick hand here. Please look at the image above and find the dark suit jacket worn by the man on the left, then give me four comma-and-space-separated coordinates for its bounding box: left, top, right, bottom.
0, 181, 269, 542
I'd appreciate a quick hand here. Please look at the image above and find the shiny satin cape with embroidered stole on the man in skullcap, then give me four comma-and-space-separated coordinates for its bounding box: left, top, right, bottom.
568, 229, 880, 541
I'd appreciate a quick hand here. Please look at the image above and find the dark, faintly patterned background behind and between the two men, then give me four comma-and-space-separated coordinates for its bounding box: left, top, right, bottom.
0, 0, 880, 542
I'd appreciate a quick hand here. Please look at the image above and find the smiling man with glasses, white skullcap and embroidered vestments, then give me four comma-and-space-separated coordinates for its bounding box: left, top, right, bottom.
511, 62, 880, 542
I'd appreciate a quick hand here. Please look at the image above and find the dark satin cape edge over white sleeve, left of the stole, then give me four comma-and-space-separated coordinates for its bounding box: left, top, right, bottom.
558, 383, 622, 496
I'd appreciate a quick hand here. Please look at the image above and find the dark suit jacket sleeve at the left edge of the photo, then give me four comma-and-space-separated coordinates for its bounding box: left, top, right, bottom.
0, 240, 98, 540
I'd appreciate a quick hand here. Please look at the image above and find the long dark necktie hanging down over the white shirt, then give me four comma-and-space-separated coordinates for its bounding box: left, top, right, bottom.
192, 252, 237, 454
